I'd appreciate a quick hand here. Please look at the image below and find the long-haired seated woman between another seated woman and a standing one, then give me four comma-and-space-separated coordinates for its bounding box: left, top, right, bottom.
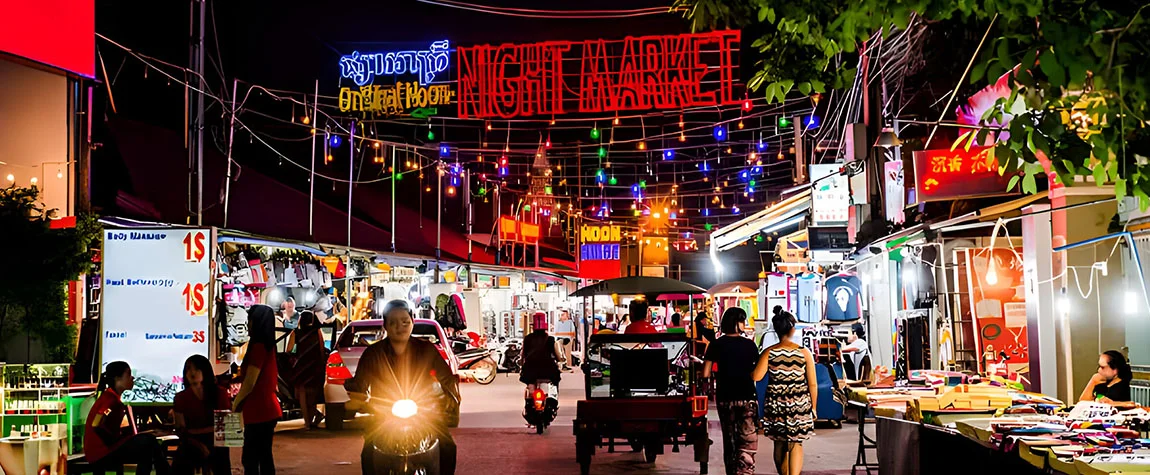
175, 354, 231, 475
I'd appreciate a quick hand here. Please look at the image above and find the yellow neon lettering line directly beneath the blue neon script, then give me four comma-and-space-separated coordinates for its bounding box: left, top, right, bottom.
339, 83, 455, 115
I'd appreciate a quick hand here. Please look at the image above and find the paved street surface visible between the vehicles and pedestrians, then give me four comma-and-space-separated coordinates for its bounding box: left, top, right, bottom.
244, 373, 874, 475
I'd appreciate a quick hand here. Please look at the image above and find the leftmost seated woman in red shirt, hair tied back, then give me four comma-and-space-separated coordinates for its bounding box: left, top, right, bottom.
84, 361, 171, 475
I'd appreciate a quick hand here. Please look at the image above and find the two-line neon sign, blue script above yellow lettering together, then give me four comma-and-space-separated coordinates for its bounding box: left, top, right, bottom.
339, 40, 455, 118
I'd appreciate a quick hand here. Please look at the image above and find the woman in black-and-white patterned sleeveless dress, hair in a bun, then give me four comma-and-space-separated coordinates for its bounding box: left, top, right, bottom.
754, 312, 819, 475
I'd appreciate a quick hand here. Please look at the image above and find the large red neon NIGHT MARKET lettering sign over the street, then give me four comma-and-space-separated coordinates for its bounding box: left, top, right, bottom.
457, 30, 741, 118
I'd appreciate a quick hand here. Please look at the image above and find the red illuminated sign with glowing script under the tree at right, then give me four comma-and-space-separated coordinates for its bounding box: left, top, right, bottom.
914, 147, 1013, 202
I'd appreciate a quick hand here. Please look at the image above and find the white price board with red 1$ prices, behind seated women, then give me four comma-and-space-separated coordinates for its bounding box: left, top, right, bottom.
100, 228, 213, 403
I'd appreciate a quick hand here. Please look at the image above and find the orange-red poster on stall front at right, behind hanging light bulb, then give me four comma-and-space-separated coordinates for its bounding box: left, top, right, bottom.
966, 247, 1030, 386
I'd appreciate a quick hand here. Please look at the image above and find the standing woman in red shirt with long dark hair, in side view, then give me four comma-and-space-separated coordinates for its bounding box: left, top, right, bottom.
232, 305, 283, 475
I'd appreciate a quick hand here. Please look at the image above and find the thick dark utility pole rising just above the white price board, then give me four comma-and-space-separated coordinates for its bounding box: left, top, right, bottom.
187, 0, 207, 225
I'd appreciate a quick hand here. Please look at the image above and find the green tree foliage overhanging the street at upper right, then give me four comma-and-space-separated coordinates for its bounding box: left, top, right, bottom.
676, 0, 1150, 201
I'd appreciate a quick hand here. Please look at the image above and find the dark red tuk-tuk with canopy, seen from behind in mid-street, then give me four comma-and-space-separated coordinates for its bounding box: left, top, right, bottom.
573, 277, 711, 475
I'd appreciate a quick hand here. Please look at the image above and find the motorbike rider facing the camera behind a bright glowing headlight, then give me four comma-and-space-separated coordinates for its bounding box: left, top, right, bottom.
353, 300, 460, 475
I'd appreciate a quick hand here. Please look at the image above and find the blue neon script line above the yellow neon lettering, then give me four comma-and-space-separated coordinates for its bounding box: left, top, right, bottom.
339, 40, 450, 86
